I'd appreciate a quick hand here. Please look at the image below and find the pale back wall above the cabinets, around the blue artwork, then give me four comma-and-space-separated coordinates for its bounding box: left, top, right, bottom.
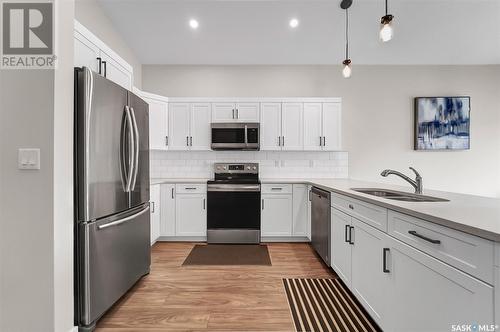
142, 64, 500, 197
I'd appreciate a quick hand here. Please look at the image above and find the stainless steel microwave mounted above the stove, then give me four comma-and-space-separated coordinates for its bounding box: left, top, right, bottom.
212, 122, 260, 151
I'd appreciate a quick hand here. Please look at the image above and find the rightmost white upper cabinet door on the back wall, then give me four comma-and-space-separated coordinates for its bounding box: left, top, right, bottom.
322, 103, 342, 151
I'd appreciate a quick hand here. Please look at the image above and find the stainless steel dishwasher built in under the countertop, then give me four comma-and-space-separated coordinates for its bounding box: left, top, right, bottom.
311, 187, 331, 266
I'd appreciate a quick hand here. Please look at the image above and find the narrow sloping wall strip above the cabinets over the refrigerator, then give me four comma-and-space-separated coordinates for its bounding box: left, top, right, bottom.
75, 0, 142, 89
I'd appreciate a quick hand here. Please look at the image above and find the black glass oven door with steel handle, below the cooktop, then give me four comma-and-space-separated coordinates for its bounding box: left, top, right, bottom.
207, 184, 260, 230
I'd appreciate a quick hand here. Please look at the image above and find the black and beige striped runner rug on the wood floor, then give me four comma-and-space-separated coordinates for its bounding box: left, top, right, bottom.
283, 279, 381, 332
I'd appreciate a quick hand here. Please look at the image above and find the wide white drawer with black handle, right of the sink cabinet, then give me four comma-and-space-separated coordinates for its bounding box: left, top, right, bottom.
388, 211, 494, 284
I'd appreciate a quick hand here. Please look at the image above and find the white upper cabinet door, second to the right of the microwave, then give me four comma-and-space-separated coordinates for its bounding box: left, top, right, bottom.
281, 103, 304, 151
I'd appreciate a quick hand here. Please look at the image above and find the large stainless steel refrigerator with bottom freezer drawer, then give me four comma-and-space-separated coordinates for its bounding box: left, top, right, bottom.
74, 67, 151, 331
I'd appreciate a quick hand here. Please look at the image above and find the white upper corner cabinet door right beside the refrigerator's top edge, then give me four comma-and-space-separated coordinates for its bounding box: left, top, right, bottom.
143, 97, 168, 150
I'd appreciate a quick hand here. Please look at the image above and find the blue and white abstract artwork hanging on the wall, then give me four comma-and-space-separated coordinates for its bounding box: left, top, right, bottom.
415, 97, 470, 150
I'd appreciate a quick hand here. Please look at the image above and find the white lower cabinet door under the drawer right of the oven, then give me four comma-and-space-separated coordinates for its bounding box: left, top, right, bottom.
261, 194, 293, 236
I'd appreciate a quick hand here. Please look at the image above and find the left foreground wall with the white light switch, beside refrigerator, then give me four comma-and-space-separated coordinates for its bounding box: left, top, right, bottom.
0, 0, 74, 332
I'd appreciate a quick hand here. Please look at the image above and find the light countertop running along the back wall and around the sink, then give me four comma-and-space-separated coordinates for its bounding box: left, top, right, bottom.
151, 178, 500, 242
